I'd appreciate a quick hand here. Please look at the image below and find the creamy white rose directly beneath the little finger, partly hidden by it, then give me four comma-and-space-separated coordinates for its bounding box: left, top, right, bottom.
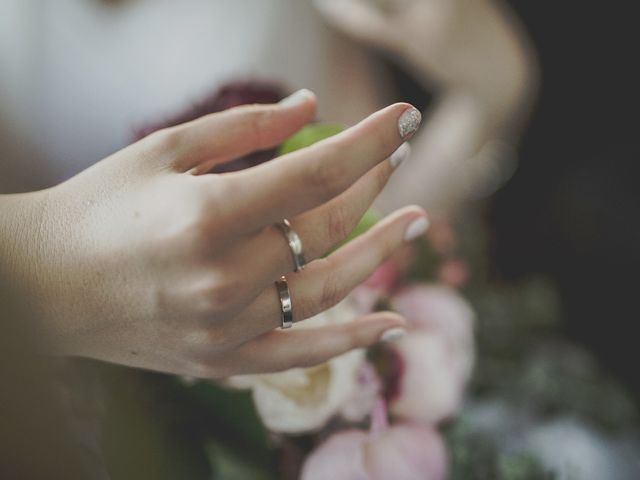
227, 299, 365, 433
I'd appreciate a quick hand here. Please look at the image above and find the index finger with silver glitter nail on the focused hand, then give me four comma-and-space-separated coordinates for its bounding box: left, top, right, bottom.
223, 103, 420, 233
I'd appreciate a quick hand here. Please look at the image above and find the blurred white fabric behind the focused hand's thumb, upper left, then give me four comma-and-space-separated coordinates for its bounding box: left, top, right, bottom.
0, 0, 382, 192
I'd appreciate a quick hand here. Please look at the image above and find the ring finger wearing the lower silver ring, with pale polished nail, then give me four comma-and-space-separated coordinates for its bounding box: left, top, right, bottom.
225, 207, 428, 338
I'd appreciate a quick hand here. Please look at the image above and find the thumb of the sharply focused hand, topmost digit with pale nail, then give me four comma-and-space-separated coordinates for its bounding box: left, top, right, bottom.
147, 89, 316, 174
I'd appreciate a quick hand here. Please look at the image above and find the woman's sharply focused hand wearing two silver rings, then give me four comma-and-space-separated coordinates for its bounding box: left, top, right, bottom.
0, 91, 426, 377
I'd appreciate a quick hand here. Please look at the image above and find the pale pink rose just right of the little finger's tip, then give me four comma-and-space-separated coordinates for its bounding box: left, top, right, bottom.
389, 285, 474, 424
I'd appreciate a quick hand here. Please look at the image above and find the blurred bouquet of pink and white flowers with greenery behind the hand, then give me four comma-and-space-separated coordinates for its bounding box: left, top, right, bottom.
92, 82, 640, 480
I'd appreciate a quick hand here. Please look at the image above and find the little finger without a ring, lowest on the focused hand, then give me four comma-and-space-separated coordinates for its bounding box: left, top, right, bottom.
238, 312, 406, 373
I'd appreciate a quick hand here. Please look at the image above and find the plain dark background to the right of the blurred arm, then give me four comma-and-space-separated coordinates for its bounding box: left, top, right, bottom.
490, 1, 640, 400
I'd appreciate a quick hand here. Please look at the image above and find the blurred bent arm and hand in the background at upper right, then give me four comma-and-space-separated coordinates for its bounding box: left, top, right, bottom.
315, 0, 537, 209
